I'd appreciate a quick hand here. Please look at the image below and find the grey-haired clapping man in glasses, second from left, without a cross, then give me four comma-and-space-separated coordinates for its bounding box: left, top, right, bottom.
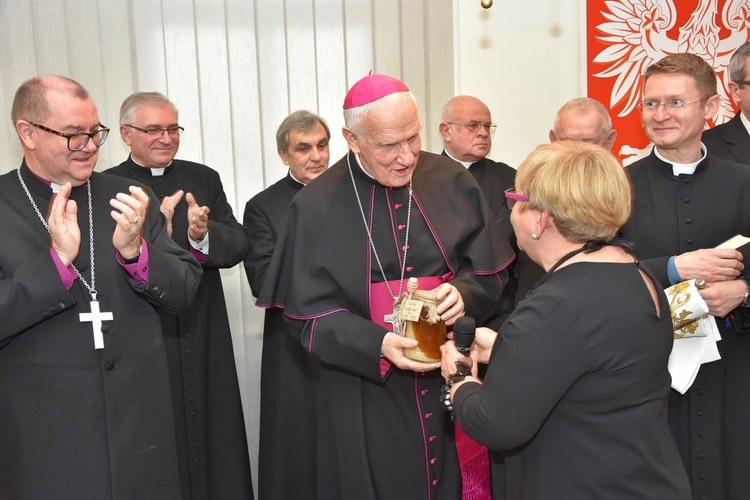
105, 92, 253, 500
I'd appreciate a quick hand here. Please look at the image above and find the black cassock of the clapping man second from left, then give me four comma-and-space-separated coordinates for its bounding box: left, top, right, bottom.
106, 158, 252, 499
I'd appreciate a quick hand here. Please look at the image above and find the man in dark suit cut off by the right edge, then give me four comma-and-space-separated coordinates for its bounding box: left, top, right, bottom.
703, 42, 750, 165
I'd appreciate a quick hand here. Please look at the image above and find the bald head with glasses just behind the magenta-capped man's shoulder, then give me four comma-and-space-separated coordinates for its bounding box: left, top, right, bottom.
440, 95, 494, 162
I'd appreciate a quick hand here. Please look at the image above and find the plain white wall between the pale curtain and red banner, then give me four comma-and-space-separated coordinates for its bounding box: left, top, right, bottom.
454, 0, 585, 167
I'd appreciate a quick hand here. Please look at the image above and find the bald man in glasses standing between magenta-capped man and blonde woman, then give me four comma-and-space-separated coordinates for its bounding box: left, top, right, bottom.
440, 95, 518, 330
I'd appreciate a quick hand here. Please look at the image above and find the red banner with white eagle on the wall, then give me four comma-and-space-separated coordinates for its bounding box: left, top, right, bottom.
586, 0, 750, 165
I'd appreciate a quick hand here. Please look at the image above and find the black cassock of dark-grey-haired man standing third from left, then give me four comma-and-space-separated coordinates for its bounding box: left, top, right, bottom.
242, 174, 320, 500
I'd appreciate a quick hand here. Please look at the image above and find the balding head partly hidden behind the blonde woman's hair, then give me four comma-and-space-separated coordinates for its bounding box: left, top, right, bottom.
549, 97, 617, 150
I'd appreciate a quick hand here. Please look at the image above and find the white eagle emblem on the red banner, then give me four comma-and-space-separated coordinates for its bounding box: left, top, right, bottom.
594, 0, 750, 165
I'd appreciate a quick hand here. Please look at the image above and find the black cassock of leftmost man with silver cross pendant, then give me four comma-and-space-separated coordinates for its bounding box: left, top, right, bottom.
0, 162, 200, 499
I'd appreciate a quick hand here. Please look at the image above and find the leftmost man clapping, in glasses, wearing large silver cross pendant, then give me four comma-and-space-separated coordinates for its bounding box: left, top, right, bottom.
0, 76, 201, 500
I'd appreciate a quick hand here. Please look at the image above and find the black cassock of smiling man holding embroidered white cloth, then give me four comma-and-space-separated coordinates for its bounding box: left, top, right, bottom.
622, 152, 750, 499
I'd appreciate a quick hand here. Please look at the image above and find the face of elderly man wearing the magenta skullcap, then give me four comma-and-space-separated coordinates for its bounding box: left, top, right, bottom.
344, 92, 422, 187
